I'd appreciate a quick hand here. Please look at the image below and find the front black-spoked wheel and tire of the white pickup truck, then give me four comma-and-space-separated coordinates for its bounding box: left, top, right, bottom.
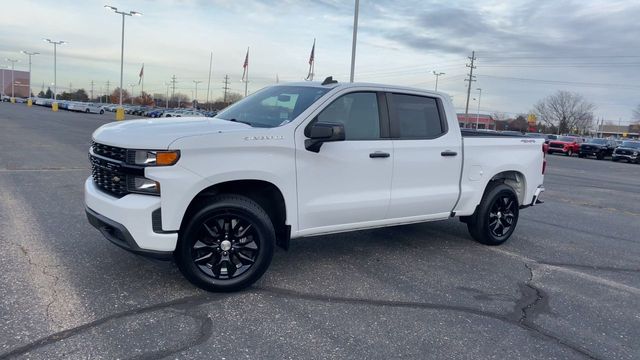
175, 194, 276, 292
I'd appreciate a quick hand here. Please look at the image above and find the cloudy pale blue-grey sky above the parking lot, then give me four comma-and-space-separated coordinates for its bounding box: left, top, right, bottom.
0, 0, 640, 123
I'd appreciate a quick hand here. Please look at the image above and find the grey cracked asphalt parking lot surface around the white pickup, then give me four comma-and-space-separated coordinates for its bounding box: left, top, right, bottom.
0, 103, 640, 359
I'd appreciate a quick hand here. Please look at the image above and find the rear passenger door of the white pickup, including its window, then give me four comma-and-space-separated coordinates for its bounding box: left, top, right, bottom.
387, 93, 462, 219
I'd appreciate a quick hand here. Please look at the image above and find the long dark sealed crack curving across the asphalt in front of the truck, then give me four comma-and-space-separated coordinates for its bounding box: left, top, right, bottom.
0, 284, 597, 360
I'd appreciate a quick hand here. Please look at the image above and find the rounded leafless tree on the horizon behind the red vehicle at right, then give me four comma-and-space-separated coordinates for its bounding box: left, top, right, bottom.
534, 91, 596, 133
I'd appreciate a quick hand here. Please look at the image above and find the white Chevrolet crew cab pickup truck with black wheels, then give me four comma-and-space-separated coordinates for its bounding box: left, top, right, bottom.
85, 78, 545, 291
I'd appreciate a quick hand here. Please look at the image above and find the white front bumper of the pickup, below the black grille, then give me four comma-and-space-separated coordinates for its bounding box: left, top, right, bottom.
84, 177, 178, 258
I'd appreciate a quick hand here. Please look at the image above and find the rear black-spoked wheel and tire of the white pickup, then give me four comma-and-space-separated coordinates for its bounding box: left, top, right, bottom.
467, 183, 519, 246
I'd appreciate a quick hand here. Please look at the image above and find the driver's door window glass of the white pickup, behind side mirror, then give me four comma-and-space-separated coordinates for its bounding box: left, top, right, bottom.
317, 92, 380, 140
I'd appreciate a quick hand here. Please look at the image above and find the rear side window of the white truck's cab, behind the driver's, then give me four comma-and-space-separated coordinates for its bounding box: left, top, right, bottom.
389, 94, 446, 139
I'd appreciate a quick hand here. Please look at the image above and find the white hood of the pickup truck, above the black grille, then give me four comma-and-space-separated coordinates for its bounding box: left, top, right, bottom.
93, 117, 252, 150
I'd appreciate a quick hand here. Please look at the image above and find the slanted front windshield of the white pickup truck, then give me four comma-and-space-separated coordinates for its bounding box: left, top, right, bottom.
216, 85, 330, 127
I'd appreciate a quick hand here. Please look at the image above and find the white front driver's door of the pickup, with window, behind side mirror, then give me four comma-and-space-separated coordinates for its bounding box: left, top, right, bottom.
296, 92, 393, 235
